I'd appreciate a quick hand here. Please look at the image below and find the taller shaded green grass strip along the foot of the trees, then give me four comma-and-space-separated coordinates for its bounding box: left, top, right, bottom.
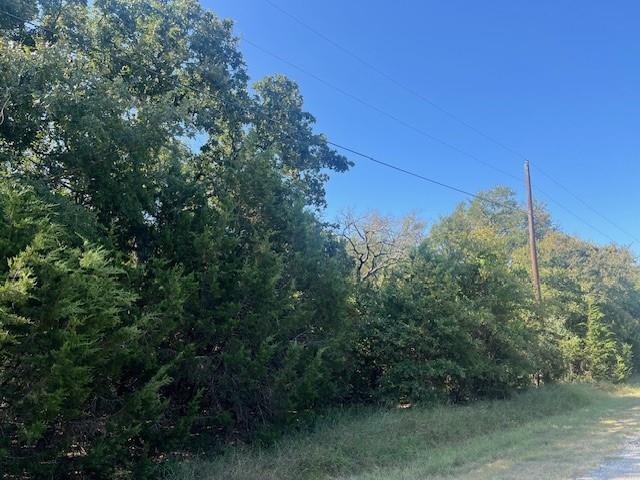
164, 384, 611, 480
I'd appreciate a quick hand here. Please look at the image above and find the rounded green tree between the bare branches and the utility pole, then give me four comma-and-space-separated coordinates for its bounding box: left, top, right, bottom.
351, 199, 536, 403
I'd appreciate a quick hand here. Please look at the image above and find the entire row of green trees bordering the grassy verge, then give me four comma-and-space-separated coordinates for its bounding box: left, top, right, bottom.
0, 0, 640, 478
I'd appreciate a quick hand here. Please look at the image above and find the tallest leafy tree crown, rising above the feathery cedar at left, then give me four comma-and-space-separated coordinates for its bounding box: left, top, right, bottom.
0, 0, 248, 256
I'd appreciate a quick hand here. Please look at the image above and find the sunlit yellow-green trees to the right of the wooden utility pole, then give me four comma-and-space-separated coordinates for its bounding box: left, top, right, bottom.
538, 232, 640, 376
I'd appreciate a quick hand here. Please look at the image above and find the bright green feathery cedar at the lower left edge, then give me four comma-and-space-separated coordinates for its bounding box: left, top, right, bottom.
0, 180, 178, 477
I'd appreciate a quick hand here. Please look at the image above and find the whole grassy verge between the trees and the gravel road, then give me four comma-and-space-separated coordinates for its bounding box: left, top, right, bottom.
165, 383, 640, 480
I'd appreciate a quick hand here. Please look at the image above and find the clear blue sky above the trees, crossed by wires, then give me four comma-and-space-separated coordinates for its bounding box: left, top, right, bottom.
204, 0, 640, 253
